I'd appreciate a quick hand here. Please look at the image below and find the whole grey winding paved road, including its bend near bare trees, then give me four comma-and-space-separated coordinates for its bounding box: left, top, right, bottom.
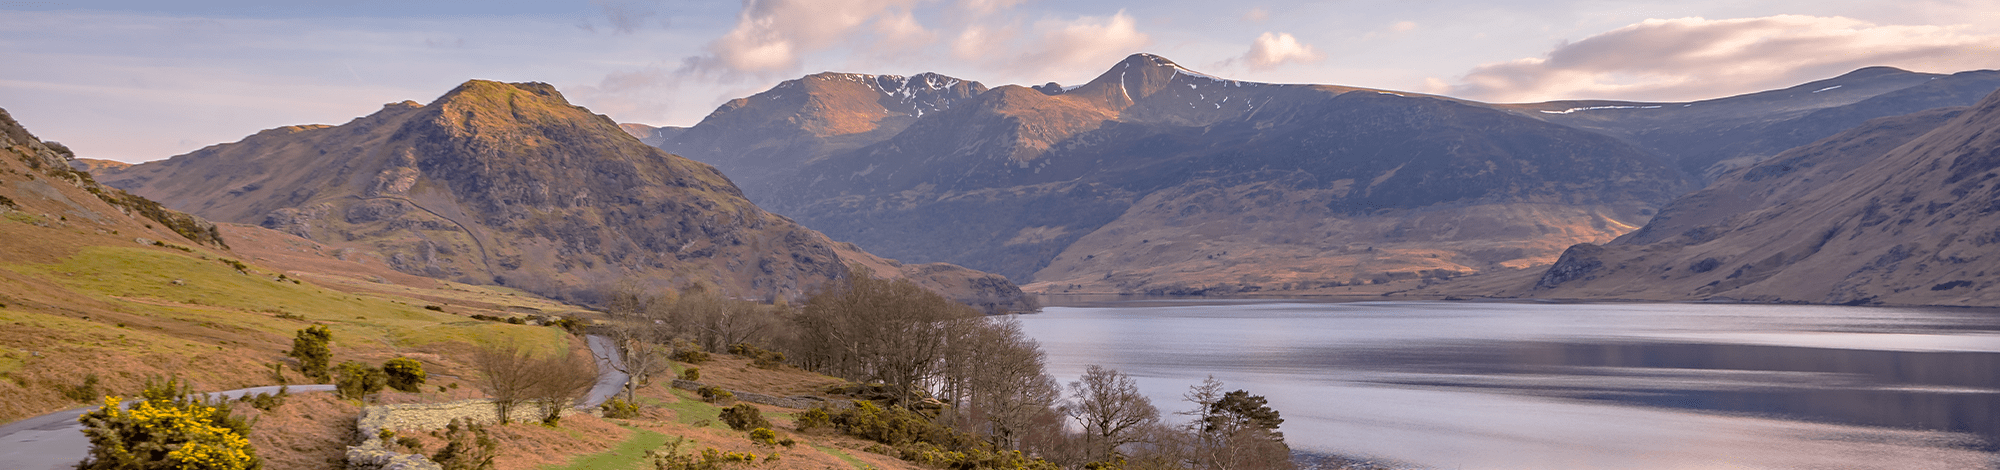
0, 334, 626, 470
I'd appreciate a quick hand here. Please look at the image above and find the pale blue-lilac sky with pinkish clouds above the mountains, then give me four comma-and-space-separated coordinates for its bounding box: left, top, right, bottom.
0, 0, 2000, 162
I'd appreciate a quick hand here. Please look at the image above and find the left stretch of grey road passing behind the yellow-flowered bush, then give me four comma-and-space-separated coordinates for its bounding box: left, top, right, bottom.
0, 386, 334, 470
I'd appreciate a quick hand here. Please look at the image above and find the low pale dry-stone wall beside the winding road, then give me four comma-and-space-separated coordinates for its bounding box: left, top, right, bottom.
348, 400, 602, 470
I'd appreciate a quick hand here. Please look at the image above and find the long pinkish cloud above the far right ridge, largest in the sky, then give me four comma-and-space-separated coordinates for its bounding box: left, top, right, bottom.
1430, 14, 2000, 102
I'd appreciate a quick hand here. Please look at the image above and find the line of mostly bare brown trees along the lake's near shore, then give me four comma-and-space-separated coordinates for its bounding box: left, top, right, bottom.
604, 268, 1292, 470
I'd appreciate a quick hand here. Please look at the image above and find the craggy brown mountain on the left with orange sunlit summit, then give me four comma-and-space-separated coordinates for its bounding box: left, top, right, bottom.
90, 80, 1022, 310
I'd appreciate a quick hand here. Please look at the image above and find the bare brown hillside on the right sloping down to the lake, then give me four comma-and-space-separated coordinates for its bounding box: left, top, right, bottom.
1510, 86, 2000, 306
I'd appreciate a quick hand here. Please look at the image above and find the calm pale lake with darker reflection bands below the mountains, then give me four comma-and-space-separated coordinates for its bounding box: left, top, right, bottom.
1020, 300, 2000, 470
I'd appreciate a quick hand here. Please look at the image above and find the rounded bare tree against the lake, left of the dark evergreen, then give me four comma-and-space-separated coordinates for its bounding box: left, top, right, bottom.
1064, 364, 1160, 462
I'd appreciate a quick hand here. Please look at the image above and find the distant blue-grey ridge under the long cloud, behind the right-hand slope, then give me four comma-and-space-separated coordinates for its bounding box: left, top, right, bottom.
1498, 66, 2000, 180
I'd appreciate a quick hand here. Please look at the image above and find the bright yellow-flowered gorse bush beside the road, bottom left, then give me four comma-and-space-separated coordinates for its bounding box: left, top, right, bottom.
76, 378, 264, 470
